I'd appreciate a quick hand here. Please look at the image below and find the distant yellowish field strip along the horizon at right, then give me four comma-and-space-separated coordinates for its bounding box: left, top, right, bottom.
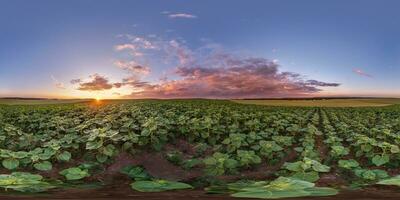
232, 99, 400, 107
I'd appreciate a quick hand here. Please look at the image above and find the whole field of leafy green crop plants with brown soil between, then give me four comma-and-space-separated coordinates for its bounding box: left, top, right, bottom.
0, 100, 400, 198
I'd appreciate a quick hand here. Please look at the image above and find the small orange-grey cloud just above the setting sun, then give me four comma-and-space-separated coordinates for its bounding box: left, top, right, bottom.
71, 74, 122, 91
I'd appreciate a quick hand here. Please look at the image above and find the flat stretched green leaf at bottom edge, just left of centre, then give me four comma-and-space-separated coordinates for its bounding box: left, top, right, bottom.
131, 180, 193, 192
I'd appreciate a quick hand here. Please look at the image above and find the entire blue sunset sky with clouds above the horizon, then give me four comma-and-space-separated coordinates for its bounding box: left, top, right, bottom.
0, 0, 400, 98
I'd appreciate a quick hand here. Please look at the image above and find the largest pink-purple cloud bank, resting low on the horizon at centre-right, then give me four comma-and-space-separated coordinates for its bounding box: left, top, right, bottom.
123, 54, 340, 98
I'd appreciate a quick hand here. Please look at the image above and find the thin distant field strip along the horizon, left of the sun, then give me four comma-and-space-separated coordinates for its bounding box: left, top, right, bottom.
0, 99, 90, 105
